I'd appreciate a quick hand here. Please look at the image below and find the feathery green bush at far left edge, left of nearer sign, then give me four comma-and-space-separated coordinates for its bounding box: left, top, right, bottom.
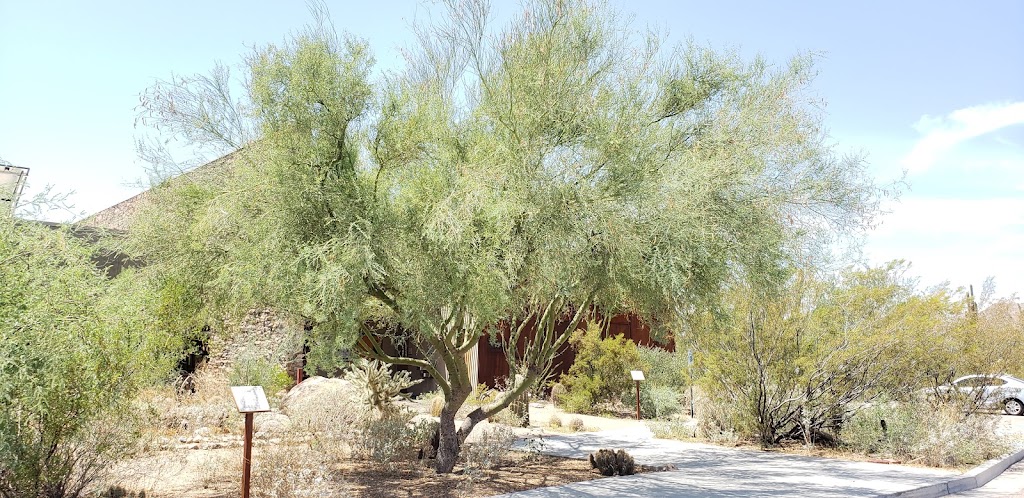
0, 220, 160, 498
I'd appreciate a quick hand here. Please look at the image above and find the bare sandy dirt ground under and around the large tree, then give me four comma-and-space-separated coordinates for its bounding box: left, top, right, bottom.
97, 402, 655, 498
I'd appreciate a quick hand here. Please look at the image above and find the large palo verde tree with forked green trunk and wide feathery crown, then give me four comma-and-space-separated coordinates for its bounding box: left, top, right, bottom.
133, 0, 877, 472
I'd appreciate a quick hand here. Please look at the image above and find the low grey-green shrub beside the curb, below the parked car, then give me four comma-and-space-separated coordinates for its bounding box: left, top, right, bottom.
840, 402, 1008, 466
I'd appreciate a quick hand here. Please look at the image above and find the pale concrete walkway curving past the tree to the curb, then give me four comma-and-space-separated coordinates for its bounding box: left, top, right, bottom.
503, 428, 956, 498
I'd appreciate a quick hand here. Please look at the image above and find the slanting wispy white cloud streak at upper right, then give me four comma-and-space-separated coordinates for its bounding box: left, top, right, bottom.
903, 101, 1024, 173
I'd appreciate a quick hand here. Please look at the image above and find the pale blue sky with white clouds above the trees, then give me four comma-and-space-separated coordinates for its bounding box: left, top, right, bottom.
0, 0, 1024, 298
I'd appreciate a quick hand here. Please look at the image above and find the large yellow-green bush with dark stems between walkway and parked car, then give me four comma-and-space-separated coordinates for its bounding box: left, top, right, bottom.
694, 262, 967, 446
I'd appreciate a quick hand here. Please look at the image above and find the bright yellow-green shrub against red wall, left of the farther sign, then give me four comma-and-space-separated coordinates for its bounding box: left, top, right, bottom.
559, 324, 640, 413
